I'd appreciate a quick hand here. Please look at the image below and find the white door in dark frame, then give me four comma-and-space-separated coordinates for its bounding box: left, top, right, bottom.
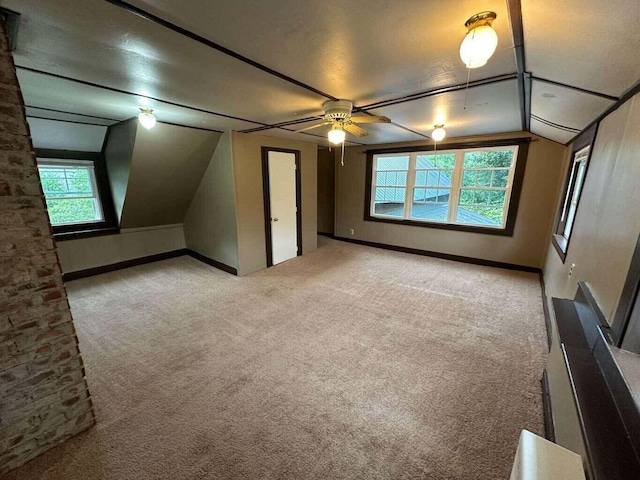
268, 151, 298, 265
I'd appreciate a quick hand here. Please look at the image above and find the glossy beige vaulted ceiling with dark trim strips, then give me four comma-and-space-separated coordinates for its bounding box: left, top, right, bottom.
5, 0, 640, 145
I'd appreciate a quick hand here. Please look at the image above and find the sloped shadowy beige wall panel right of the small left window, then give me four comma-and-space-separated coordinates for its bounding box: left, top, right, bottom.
120, 123, 221, 228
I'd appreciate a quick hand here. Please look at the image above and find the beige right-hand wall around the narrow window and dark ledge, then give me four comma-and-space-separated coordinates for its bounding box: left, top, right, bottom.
544, 91, 640, 462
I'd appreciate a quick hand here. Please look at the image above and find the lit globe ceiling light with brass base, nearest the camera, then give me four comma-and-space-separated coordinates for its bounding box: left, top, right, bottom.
460, 12, 498, 68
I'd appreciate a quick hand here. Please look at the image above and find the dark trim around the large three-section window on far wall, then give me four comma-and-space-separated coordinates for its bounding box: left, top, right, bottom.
364, 137, 531, 237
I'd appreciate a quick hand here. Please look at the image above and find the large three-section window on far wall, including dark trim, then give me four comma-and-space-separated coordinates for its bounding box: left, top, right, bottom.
365, 143, 527, 235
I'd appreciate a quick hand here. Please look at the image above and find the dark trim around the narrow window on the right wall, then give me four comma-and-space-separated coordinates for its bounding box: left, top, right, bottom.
551, 123, 599, 264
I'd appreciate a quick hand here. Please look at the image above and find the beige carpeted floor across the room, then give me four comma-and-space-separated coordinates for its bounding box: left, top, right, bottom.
6, 238, 546, 480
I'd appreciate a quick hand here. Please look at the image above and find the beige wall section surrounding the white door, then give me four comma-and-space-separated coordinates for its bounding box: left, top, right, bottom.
233, 132, 318, 275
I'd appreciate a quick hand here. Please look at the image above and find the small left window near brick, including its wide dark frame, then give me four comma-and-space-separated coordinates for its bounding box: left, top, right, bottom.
36, 150, 115, 239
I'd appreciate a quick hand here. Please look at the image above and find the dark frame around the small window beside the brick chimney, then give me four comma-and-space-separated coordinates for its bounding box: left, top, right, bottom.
35, 148, 119, 241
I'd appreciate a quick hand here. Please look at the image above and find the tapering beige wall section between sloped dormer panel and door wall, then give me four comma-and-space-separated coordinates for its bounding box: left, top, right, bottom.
184, 132, 238, 269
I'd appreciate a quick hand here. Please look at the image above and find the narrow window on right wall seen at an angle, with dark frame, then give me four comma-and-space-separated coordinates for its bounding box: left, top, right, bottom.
552, 126, 596, 262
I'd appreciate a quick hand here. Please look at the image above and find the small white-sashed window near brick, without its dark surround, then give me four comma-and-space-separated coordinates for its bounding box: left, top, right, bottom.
38, 159, 104, 226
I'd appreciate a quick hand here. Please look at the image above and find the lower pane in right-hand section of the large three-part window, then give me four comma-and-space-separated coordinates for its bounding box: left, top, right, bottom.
456, 189, 506, 226
